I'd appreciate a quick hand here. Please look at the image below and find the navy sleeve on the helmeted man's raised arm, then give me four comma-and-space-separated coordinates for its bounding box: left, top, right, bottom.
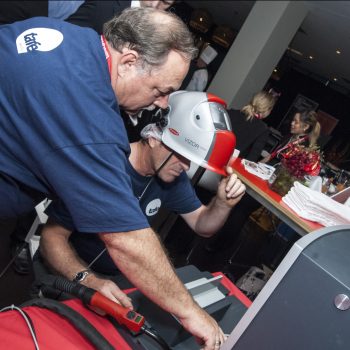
164, 173, 202, 214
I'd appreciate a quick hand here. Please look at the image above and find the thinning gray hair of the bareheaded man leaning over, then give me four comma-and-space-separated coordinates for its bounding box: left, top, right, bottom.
103, 7, 197, 68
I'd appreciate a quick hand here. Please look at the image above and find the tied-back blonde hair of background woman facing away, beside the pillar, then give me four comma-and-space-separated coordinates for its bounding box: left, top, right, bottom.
241, 91, 277, 120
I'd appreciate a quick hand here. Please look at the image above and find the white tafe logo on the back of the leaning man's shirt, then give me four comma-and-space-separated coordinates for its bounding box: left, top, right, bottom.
16, 28, 63, 53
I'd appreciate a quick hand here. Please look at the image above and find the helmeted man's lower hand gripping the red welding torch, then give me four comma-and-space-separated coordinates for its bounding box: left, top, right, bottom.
81, 274, 133, 309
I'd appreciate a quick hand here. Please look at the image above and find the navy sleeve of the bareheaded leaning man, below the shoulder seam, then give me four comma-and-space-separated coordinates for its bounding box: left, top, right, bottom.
43, 144, 149, 232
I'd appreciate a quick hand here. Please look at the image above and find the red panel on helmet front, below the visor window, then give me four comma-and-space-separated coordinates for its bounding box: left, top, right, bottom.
207, 130, 236, 176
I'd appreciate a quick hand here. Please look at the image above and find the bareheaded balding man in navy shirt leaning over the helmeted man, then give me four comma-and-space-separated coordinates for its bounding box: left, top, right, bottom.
0, 8, 224, 349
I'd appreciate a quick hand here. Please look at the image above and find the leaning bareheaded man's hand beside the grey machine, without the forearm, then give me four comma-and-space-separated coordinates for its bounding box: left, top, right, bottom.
180, 307, 226, 350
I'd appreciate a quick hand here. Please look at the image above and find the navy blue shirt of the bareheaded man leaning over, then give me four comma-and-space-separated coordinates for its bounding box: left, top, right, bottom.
0, 17, 148, 232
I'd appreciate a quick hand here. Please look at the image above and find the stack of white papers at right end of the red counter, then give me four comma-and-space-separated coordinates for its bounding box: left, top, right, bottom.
282, 182, 350, 226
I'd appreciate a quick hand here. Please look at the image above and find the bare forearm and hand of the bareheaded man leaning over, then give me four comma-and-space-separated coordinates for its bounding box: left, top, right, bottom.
100, 229, 228, 350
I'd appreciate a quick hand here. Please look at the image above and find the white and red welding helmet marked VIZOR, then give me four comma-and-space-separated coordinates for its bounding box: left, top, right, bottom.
162, 91, 236, 175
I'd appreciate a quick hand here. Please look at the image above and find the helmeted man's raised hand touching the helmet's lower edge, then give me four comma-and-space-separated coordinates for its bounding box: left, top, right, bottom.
216, 166, 245, 208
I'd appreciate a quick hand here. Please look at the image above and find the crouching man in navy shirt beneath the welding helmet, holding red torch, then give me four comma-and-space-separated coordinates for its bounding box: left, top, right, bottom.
36, 114, 245, 282
